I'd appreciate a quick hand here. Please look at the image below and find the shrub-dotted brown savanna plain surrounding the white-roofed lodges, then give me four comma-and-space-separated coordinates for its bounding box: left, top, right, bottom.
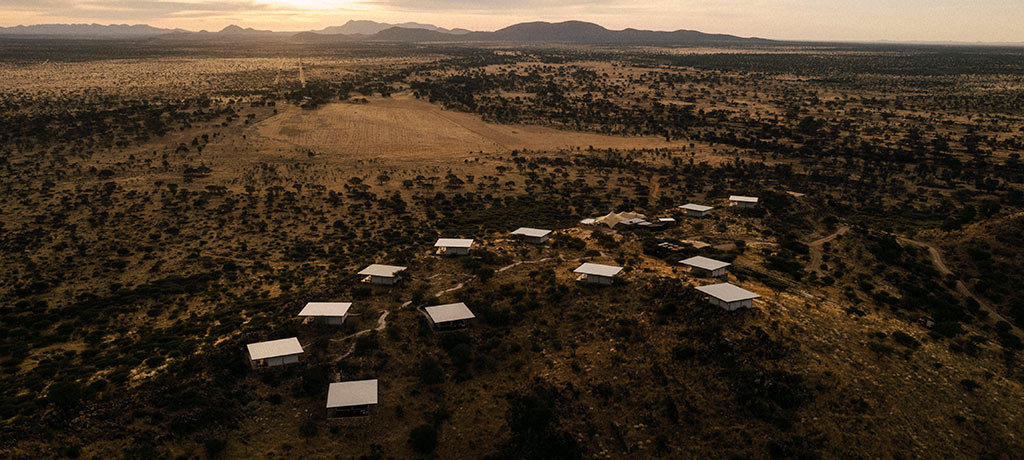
0, 42, 1024, 460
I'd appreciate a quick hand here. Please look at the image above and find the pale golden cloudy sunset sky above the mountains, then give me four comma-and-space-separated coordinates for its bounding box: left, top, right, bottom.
0, 0, 1024, 43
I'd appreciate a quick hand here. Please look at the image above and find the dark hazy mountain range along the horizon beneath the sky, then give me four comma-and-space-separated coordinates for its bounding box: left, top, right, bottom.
0, 20, 768, 45
